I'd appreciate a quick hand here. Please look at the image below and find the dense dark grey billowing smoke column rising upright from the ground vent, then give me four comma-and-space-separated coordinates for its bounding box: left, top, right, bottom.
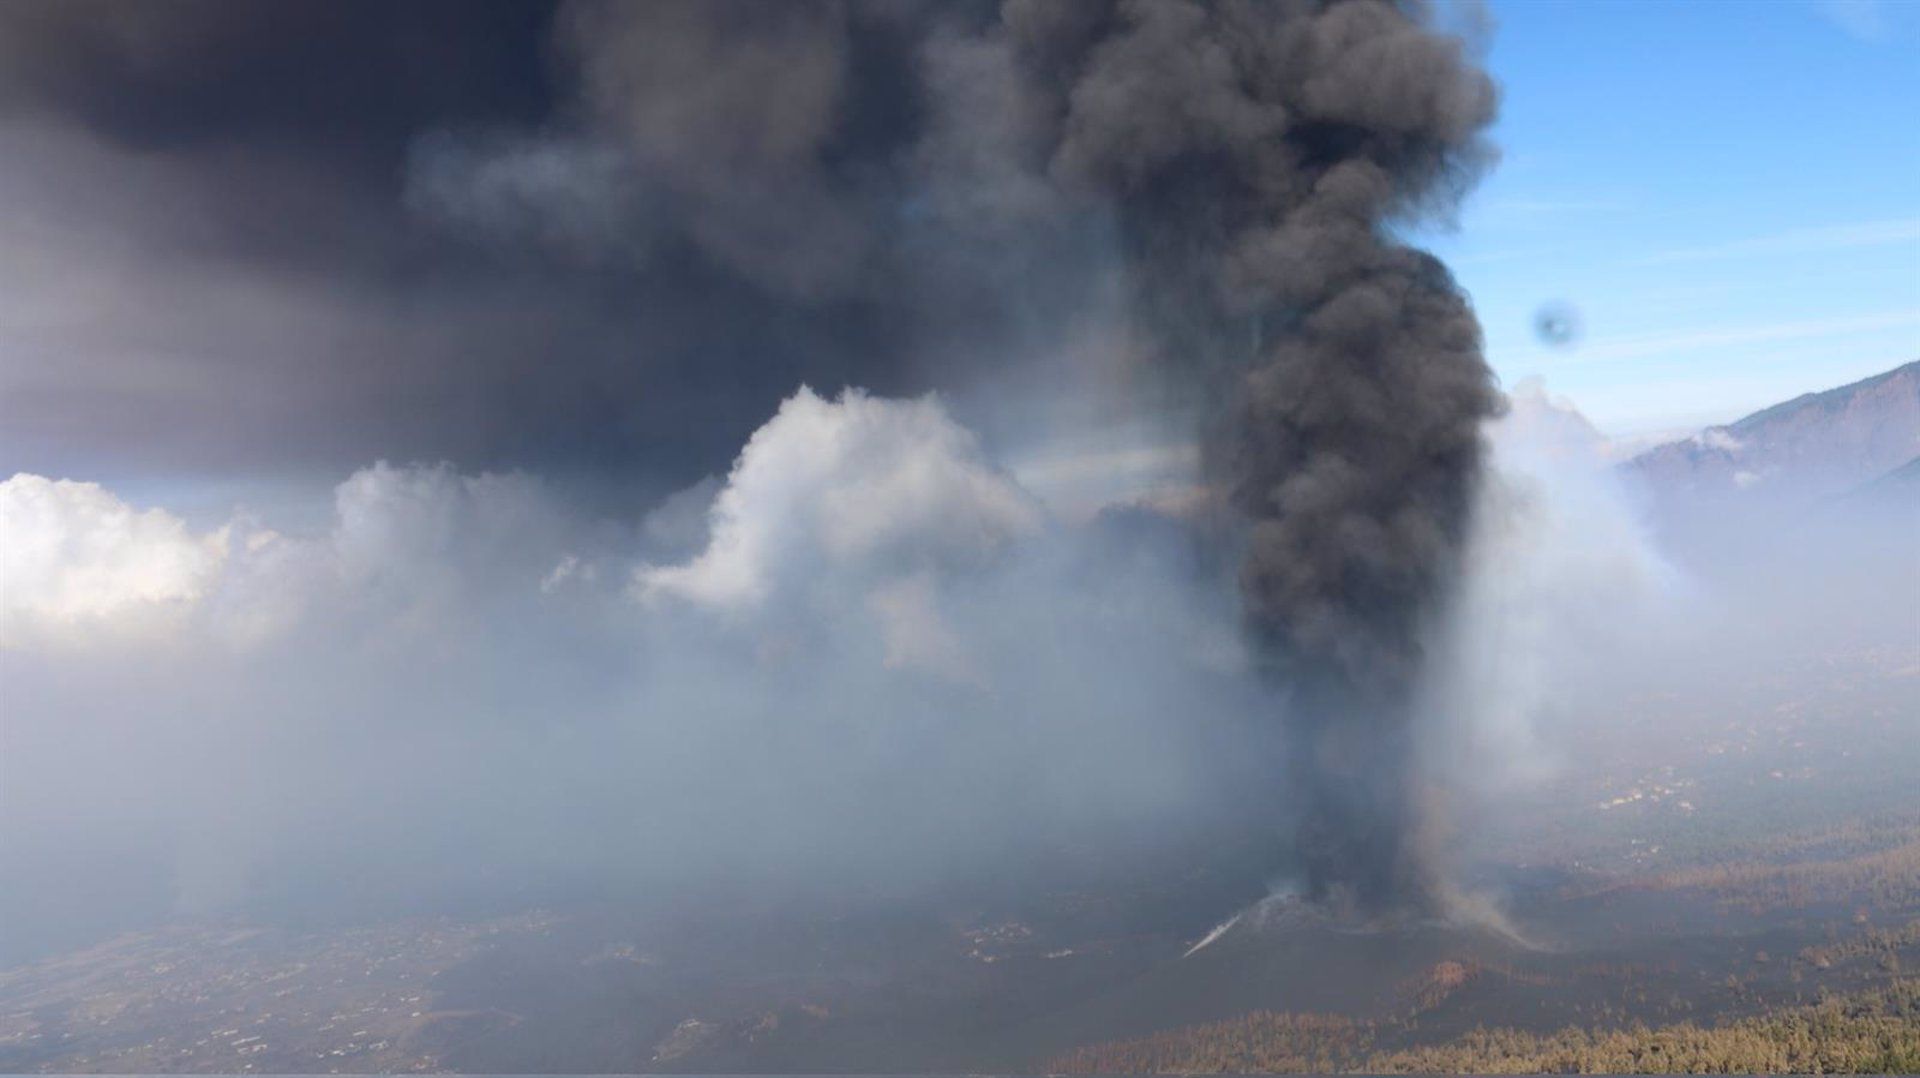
1006, 0, 1500, 913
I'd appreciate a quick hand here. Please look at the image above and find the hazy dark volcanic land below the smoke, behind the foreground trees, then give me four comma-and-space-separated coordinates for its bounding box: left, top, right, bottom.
0, 637, 1920, 1072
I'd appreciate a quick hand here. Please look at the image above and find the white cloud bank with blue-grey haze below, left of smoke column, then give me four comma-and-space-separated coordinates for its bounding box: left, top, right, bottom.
0, 392, 1269, 926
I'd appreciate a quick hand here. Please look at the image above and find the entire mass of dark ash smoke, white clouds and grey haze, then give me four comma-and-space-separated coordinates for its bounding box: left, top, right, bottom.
0, 0, 1904, 976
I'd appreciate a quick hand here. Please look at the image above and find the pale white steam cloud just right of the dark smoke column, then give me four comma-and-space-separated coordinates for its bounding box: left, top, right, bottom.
1434, 382, 1676, 786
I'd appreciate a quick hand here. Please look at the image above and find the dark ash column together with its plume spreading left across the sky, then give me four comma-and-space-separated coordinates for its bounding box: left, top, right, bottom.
0, 0, 1494, 907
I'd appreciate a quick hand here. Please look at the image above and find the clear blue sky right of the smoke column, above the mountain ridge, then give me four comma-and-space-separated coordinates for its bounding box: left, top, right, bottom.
1421, 0, 1920, 436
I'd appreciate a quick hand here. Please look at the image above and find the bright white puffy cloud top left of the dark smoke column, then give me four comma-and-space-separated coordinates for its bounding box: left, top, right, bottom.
636, 388, 1043, 611
